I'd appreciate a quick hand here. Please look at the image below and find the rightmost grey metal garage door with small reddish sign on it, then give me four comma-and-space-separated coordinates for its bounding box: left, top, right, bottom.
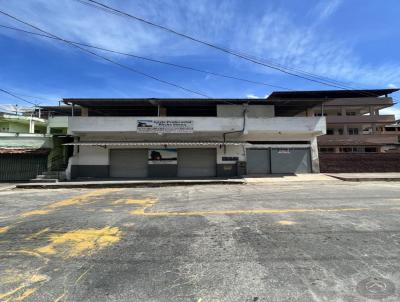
271, 148, 311, 174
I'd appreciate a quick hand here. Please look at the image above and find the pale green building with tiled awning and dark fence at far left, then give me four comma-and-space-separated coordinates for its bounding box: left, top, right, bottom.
0, 112, 52, 181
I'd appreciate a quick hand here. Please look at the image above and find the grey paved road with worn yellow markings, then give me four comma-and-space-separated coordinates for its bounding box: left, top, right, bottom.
0, 181, 400, 302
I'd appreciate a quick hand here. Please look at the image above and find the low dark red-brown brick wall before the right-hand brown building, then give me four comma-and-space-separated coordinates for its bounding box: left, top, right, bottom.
319, 153, 400, 173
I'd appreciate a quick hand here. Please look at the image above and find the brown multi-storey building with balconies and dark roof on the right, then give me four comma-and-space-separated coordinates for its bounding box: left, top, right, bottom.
270, 89, 400, 172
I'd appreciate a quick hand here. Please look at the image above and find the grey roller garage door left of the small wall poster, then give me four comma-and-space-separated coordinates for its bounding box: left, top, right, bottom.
110, 149, 147, 178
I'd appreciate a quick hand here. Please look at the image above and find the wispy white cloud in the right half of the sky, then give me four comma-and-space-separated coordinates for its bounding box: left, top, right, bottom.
232, 8, 400, 89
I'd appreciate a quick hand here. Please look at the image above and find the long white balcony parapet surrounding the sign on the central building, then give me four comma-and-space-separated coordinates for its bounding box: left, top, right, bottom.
68, 116, 326, 135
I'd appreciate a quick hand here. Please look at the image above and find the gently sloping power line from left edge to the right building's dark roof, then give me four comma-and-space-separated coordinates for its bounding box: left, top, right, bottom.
0, 24, 293, 90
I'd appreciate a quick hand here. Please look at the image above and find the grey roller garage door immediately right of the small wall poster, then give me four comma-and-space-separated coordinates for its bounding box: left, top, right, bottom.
178, 149, 217, 177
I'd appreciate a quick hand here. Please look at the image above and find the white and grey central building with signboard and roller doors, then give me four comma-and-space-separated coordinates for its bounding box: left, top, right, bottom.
53, 97, 326, 179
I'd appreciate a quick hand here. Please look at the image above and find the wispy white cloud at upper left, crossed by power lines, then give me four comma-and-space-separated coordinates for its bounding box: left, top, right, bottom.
0, 0, 236, 56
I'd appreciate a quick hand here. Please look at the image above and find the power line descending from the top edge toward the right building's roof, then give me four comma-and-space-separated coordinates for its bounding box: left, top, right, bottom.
76, 0, 396, 100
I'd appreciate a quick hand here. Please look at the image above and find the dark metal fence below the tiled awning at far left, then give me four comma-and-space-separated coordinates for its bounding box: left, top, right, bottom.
0, 154, 47, 182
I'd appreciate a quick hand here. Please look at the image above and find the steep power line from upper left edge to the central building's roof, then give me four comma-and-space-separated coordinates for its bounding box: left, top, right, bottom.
0, 10, 211, 98
